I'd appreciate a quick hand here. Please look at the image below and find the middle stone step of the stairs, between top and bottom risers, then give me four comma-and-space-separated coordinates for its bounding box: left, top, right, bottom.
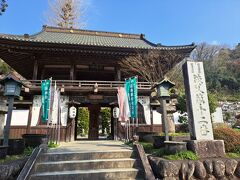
35, 158, 140, 172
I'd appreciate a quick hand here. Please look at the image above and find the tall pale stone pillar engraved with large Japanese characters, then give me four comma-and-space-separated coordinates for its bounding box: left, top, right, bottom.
183, 61, 213, 140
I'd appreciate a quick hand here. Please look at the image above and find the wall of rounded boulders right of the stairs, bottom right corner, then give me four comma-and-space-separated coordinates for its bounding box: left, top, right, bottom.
148, 156, 240, 180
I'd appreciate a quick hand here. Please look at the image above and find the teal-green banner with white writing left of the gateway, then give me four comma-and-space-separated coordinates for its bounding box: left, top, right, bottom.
41, 80, 51, 122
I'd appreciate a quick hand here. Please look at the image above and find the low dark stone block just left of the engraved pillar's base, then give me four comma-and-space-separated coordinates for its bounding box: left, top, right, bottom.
164, 141, 187, 154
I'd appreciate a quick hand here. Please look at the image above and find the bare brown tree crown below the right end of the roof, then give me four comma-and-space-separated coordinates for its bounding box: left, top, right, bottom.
119, 50, 184, 86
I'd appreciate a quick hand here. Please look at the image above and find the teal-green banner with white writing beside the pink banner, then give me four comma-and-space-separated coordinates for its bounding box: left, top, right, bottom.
125, 77, 138, 118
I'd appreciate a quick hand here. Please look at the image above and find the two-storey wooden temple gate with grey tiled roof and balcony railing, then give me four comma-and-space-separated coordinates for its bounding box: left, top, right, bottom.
0, 26, 195, 141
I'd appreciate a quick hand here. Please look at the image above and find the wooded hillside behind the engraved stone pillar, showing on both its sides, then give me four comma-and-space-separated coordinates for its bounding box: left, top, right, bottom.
167, 43, 240, 101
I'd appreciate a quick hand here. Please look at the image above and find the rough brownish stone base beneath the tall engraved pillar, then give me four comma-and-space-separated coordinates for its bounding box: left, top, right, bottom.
187, 140, 225, 158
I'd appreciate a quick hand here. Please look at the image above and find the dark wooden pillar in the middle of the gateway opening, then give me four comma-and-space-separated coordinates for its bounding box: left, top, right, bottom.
88, 104, 101, 140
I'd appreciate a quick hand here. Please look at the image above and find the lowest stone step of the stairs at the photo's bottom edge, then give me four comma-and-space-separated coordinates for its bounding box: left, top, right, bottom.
30, 168, 144, 180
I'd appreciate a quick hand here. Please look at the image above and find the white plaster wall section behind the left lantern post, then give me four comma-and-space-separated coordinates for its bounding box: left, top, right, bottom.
4, 110, 29, 126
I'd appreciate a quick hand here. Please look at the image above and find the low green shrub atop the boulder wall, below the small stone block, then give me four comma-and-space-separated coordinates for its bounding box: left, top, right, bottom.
163, 151, 199, 160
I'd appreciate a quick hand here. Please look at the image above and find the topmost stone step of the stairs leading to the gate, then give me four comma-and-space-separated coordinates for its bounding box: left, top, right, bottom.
40, 150, 136, 162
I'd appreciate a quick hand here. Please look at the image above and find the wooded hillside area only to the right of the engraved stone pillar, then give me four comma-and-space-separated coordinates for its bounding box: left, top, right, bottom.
204, 44, 240, 101
